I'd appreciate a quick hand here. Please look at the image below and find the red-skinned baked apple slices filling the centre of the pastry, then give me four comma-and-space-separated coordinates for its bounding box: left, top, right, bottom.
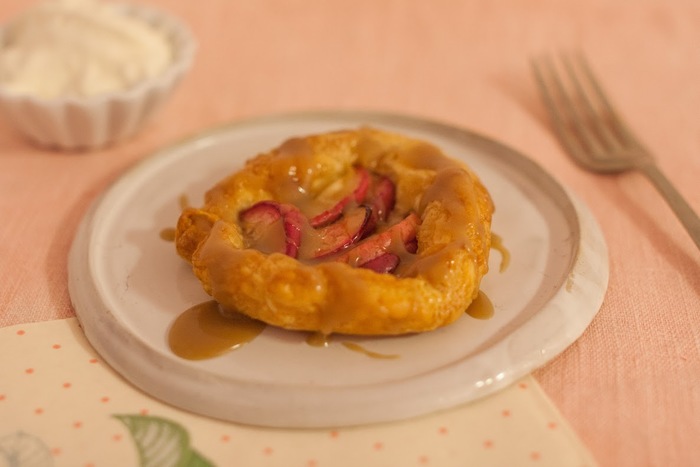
238, 166, 420, 273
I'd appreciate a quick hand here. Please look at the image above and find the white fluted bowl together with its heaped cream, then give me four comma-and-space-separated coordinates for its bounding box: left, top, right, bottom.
0, 0, 195, 149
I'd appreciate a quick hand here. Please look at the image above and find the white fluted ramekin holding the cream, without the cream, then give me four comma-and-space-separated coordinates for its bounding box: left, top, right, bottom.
0, 4, 196, 150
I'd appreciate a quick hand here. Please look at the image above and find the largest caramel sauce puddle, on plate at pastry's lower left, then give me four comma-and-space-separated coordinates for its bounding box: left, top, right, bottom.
168, 300, 267, 360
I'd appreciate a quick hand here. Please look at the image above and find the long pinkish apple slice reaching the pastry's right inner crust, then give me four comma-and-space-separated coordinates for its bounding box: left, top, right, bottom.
337, 212, 420, 266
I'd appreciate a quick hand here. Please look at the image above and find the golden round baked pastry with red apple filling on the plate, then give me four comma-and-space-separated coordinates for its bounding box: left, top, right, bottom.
175, 128, 493, 335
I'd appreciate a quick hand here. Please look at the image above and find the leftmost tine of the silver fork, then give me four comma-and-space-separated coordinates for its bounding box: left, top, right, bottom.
531, 58, 588, 166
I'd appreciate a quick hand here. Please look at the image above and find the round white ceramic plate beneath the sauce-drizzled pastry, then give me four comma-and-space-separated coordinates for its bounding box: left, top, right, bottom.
69, 112, 608, 427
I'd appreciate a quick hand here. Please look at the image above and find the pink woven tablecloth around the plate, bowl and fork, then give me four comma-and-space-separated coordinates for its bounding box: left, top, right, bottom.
0, 0, 700, 467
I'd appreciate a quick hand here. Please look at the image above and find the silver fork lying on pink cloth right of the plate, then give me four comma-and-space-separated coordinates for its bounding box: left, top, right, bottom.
532, 53, 700, 248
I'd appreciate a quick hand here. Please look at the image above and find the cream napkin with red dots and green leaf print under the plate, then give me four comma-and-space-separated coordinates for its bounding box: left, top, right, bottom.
0, 318, 595, 467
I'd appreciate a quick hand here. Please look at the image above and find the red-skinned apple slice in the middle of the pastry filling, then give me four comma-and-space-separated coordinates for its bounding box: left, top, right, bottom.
310, 206, 372, 258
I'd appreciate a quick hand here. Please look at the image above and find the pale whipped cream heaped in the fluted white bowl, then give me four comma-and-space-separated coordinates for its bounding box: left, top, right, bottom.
0, 0, 173, 98
